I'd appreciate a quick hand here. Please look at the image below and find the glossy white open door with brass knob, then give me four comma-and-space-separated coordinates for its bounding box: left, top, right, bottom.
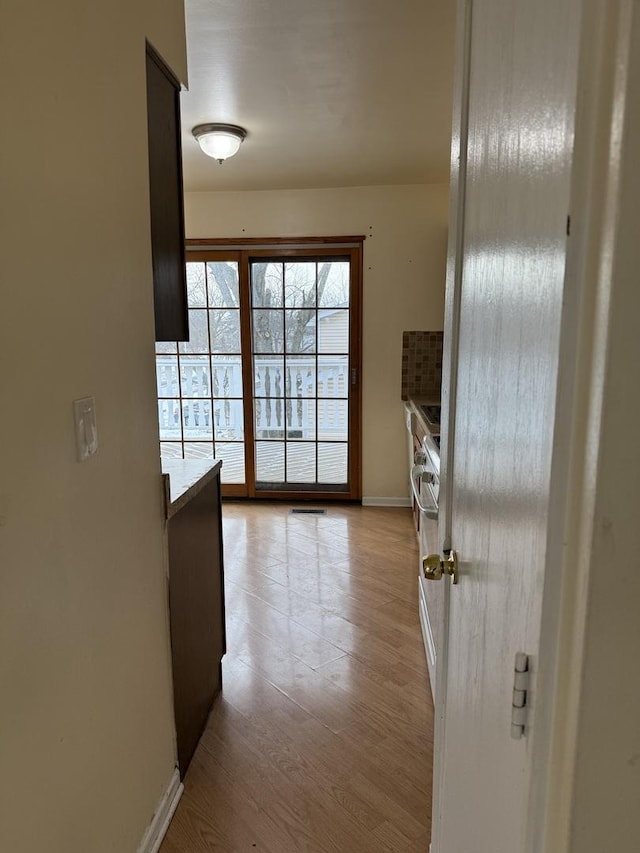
432, 0, 580, 853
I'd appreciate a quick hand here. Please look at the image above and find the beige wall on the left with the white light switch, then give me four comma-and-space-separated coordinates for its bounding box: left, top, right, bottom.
0, 0, 186, 853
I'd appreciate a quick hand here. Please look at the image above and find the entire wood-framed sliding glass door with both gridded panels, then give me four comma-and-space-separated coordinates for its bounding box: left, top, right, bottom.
156, 241, 361, 499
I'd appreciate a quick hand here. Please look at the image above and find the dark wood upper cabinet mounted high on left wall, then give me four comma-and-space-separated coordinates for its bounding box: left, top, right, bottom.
147, 45, 189, 341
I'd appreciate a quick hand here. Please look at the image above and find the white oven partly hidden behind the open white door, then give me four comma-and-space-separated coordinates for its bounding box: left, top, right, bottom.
410, 435, 444, 700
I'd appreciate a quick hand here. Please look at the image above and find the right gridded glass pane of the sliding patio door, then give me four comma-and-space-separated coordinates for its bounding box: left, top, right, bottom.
250, 257, 351, 492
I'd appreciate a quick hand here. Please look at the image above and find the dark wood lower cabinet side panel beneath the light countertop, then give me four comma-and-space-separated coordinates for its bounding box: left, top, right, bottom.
167, 473, 226, 778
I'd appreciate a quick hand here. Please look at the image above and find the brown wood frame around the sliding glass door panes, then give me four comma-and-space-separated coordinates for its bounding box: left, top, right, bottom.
185, 236, 365, 502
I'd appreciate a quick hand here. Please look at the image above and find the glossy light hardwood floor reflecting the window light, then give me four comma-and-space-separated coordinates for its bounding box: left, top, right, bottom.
161, 502, 433, 853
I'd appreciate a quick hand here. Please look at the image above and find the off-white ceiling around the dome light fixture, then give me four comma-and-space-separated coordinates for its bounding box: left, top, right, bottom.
182, 0, 455, 191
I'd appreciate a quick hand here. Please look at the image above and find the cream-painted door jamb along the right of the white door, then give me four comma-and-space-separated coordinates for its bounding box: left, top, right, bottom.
525, 0, 638, 853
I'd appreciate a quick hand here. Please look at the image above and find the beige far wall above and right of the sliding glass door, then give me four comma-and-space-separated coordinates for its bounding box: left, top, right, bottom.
185, 183, 448, 498
